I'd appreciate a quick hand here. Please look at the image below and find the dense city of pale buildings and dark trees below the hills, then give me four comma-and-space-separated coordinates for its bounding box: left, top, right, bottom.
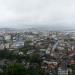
0, 31, 75, 75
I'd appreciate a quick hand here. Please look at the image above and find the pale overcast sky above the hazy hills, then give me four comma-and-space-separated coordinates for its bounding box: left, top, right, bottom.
0, 0, 75, 27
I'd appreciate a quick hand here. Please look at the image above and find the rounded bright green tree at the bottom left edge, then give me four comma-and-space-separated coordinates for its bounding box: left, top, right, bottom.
3, 64, 26, 75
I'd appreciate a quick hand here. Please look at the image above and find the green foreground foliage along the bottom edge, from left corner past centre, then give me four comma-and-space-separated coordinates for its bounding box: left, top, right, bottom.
0, 64, 44, 75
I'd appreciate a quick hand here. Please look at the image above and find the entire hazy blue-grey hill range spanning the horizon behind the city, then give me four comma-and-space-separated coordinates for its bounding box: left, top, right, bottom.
0, 25, 75, 32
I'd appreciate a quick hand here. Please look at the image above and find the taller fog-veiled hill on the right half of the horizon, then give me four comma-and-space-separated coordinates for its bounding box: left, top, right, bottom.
28, 25, 75, 31
